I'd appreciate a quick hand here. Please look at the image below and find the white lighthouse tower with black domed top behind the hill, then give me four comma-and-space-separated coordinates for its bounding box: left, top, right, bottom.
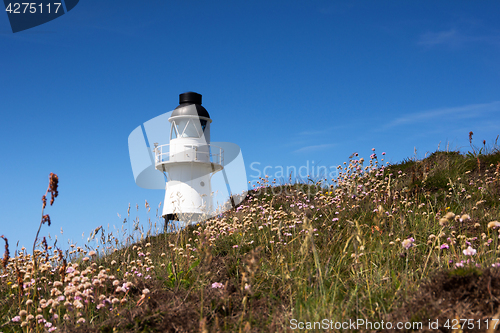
154, 92, 224, 223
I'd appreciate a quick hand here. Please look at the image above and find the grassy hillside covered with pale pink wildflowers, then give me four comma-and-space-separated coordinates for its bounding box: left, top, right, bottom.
0, 136, 500, 332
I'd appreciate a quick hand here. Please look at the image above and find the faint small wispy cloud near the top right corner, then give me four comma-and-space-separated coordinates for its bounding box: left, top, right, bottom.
417, 29, 500, 47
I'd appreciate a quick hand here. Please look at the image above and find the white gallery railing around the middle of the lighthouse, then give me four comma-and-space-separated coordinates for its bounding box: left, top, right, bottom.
154, 144, 224, 165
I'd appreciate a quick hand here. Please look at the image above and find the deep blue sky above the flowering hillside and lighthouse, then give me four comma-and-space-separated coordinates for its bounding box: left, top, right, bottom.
0, 0, 500, 251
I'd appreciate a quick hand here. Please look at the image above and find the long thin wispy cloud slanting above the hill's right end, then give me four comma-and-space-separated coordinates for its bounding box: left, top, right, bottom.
384, 101, 500, 130
